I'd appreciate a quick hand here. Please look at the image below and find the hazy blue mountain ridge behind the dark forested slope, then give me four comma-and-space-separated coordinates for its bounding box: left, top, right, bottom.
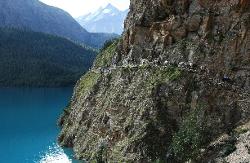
0, 0, 116, 47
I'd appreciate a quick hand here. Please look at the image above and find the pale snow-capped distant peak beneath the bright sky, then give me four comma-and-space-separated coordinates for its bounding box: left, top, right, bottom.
76, 4, 128, 34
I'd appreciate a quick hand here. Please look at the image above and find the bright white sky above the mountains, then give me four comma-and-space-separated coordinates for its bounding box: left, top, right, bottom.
40, 0, 130, 17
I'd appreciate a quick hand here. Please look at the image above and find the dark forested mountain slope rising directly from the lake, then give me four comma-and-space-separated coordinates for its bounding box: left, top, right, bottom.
0, 28, 96, 87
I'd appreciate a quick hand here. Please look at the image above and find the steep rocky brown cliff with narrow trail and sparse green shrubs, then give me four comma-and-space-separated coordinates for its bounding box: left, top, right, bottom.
59, 0, 250, 162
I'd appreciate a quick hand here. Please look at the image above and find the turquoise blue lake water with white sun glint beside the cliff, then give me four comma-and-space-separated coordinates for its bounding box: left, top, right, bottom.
0, 88, 82, 163
